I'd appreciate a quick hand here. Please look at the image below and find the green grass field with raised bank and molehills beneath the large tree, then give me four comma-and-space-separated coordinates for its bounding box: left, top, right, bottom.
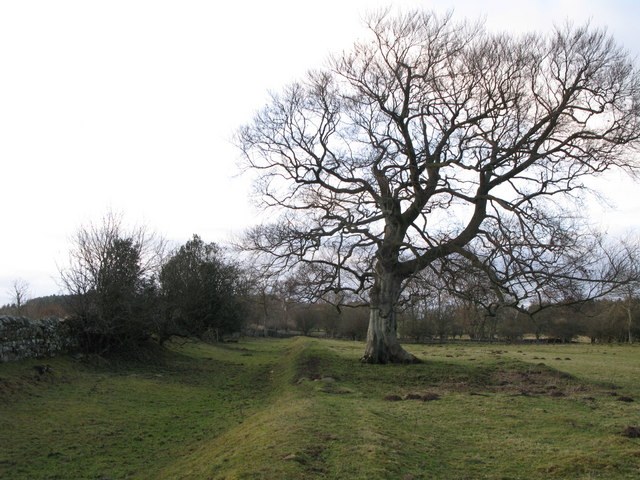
0, 338, 640, 480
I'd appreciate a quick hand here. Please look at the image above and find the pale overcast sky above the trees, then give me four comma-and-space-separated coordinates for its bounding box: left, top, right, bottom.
0, 0, 640, 305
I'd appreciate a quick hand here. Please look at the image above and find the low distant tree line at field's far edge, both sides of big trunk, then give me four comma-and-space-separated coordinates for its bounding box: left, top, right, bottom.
245, 297, 640, 343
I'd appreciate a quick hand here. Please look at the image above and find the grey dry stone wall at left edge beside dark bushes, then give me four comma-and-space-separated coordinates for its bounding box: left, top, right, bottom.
0, 316, 77, 362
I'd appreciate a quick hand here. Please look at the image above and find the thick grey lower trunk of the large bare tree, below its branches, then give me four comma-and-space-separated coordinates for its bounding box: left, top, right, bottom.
362, 273, 419, 363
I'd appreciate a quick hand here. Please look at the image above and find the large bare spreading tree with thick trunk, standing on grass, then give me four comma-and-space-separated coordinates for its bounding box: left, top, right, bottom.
238, 11, 640, 363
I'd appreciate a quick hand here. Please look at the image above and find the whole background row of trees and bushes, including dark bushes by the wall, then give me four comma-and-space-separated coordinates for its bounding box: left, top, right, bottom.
6, 214, 640, 354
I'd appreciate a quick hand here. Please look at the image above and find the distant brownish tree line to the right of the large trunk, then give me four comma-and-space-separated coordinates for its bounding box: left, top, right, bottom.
399, 258, 640, 343
